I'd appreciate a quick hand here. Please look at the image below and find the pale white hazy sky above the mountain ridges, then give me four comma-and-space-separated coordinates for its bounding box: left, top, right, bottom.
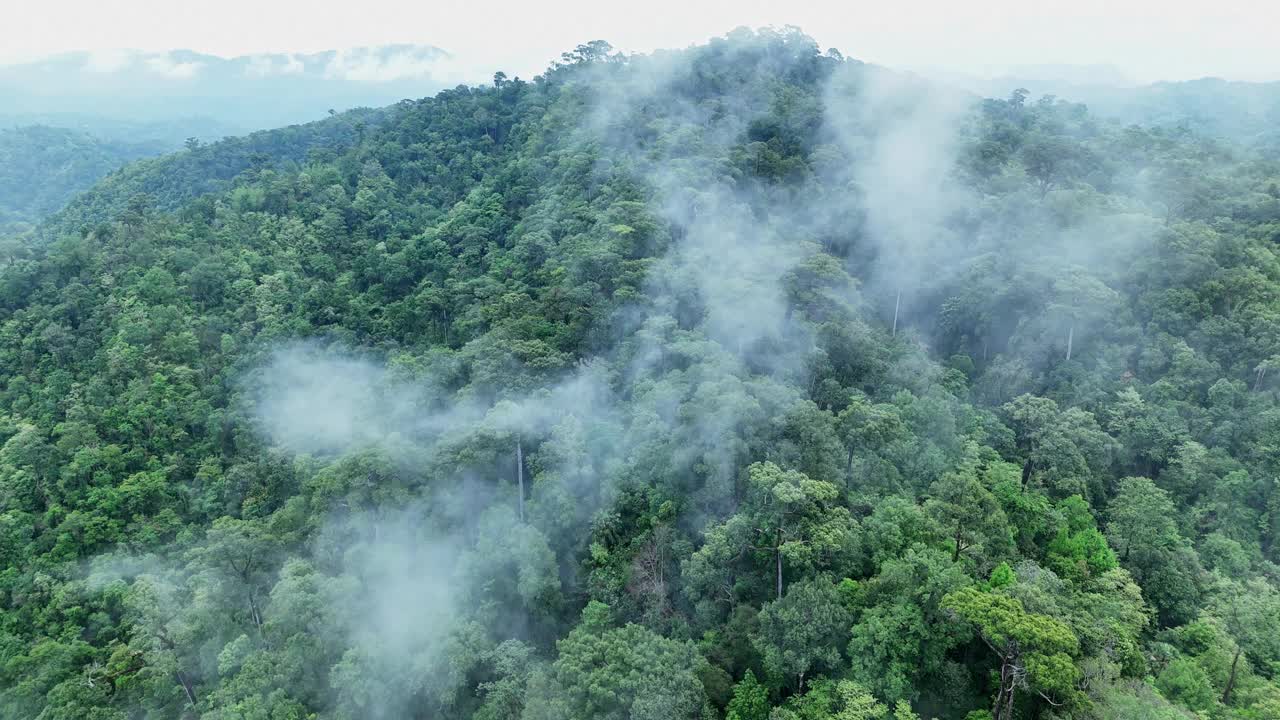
0, 0, 1280, 81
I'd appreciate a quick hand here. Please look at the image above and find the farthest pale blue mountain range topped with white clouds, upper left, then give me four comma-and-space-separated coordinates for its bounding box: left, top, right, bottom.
0, 45, 453, 135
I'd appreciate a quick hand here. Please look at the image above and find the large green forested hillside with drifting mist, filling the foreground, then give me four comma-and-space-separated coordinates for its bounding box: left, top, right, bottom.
0, 31, 1280, 720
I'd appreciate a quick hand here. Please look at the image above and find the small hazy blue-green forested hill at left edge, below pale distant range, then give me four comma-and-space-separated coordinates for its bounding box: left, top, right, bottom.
0, 126, 169, 234
